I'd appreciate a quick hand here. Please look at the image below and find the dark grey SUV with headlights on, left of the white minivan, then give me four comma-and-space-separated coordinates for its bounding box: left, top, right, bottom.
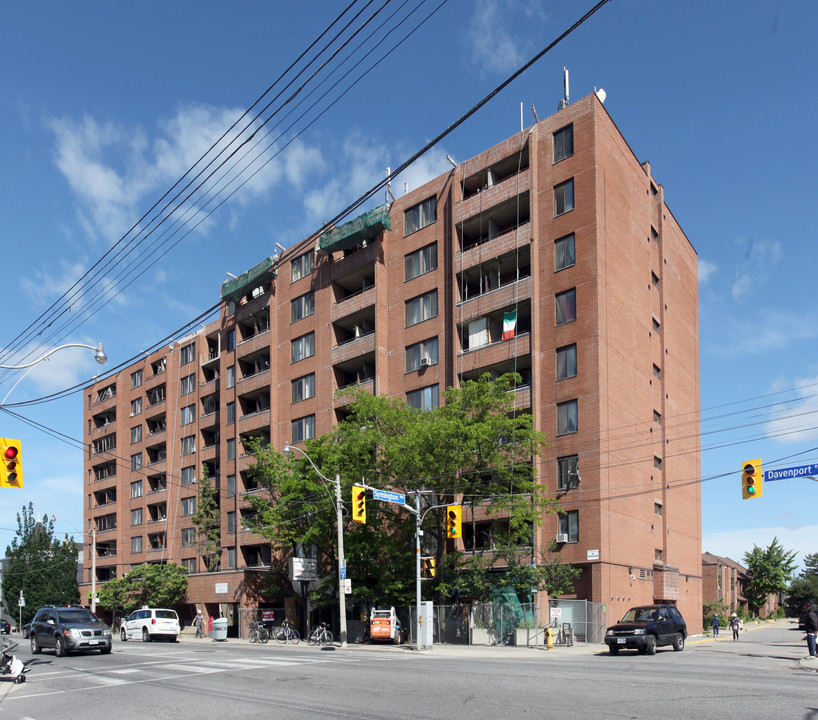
30, 605, 111, 657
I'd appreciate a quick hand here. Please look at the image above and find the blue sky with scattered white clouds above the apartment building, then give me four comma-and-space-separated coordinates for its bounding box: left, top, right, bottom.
0, 0, 818, 572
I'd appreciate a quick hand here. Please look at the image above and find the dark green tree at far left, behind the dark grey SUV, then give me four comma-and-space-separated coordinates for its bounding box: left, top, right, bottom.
3, 503, 79, 623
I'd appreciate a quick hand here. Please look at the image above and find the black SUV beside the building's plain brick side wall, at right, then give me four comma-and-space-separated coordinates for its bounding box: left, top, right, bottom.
605, 605, 687, 655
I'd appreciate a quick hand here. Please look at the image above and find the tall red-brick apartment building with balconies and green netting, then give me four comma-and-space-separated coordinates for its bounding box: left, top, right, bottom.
83, 95, 702, 631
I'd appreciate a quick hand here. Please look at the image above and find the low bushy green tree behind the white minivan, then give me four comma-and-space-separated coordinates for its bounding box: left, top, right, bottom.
97, 563, 187, 615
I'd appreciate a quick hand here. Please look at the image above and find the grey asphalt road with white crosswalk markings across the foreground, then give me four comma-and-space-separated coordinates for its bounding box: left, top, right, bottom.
0, 623, 818, 720
